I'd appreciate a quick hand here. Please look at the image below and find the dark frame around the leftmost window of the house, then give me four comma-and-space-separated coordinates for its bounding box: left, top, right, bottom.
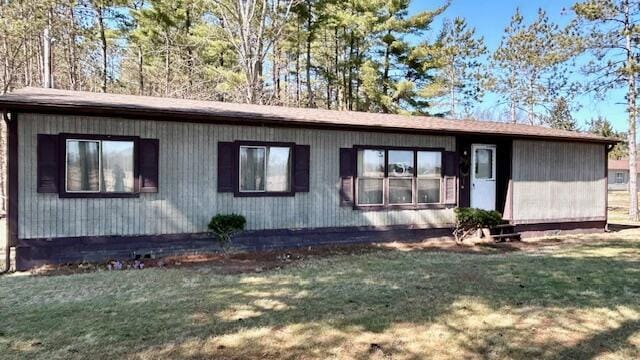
58, 133, 140, 198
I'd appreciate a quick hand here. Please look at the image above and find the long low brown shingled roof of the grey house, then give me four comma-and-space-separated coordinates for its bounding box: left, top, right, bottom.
0, 87, 617, 143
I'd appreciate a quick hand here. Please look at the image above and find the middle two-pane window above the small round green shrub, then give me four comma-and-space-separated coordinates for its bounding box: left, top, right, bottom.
239, 145, 291, 193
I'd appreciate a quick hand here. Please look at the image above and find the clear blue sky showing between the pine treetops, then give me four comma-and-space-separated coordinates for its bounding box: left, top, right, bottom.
409, 0, 627, 131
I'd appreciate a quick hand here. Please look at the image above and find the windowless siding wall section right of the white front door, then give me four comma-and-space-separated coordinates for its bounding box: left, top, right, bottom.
512, 140, 607, 223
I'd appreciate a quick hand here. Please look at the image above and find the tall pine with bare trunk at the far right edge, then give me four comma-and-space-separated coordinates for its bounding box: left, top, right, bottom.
573, 0, 640, 221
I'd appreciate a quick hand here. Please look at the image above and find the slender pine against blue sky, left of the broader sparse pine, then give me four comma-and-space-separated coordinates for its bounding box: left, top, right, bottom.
438, 18, 487, 118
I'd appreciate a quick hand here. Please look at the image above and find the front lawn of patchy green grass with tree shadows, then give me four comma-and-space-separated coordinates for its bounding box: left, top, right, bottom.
0, 230, 640, 359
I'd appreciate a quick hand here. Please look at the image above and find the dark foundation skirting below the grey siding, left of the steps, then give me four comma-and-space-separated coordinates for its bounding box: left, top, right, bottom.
16, 226, 451, 270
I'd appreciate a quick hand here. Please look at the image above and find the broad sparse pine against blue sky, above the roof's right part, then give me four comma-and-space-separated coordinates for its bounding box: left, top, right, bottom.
490, 9, 578, 124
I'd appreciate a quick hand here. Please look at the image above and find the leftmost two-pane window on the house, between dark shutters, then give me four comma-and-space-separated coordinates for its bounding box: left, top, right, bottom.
65, 138, 135, 194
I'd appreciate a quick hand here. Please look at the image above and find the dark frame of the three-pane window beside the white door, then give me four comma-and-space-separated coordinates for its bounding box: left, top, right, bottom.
353, 145, 453, 211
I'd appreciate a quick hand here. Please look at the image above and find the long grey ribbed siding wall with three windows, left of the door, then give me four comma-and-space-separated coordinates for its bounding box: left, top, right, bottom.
18, 114, 455, 239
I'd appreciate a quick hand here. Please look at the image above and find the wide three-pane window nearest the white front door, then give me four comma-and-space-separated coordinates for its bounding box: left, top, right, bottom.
356, 148, 442, 207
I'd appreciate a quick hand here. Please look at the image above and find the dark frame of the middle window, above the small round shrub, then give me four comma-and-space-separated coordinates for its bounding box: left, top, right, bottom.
233, 141, 296, 197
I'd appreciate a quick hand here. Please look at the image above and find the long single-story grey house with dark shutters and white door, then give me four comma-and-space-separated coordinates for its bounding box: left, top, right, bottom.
0, 88, 615, 269
